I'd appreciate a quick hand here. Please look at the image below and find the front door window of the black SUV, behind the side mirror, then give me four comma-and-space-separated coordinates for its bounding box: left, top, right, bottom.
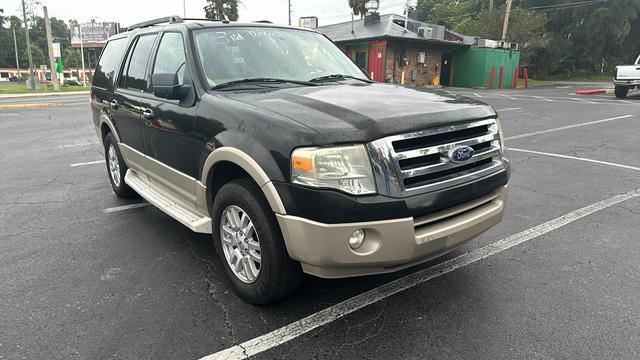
153, 33, 186, 85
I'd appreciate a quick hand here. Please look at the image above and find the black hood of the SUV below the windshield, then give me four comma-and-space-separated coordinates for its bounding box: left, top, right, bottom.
225, 84, 496, 142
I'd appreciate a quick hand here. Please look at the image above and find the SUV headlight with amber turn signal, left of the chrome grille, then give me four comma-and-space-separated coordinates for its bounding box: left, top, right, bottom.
291, 145, 376, 195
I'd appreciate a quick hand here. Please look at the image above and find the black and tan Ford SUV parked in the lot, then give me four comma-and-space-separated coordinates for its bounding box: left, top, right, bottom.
91, 16, 509, 303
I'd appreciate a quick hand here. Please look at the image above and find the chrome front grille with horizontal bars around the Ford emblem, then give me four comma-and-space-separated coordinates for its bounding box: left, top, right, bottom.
368, 119, 502, 197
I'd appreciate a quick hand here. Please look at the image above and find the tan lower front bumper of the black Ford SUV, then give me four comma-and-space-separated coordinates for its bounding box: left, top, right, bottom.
276, 185, 507, 278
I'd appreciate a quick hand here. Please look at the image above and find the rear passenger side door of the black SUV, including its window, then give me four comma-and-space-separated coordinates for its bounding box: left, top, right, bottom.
110, 33, 157, 170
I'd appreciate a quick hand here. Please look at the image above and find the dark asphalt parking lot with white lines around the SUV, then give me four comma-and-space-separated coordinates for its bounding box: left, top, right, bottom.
0, 85, 640, 359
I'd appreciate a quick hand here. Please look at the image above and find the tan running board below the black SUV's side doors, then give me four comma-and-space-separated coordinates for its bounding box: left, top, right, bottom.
124, 169, 211, 234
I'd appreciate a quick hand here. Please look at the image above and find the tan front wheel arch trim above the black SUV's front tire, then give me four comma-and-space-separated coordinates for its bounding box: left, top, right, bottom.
201, 147, 286, 215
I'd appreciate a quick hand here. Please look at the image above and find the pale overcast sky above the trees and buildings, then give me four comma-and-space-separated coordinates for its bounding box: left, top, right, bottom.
0, 0, 404, 26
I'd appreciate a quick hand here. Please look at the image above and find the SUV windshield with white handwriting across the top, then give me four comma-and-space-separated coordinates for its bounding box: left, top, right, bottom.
195, 27, 366, 87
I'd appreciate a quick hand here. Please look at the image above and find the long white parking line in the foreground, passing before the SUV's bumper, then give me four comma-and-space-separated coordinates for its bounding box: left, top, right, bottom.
201, 189, 640, 360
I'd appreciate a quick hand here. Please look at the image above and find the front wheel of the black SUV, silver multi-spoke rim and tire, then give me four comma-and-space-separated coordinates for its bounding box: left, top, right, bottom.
211, 179, 302, 304
